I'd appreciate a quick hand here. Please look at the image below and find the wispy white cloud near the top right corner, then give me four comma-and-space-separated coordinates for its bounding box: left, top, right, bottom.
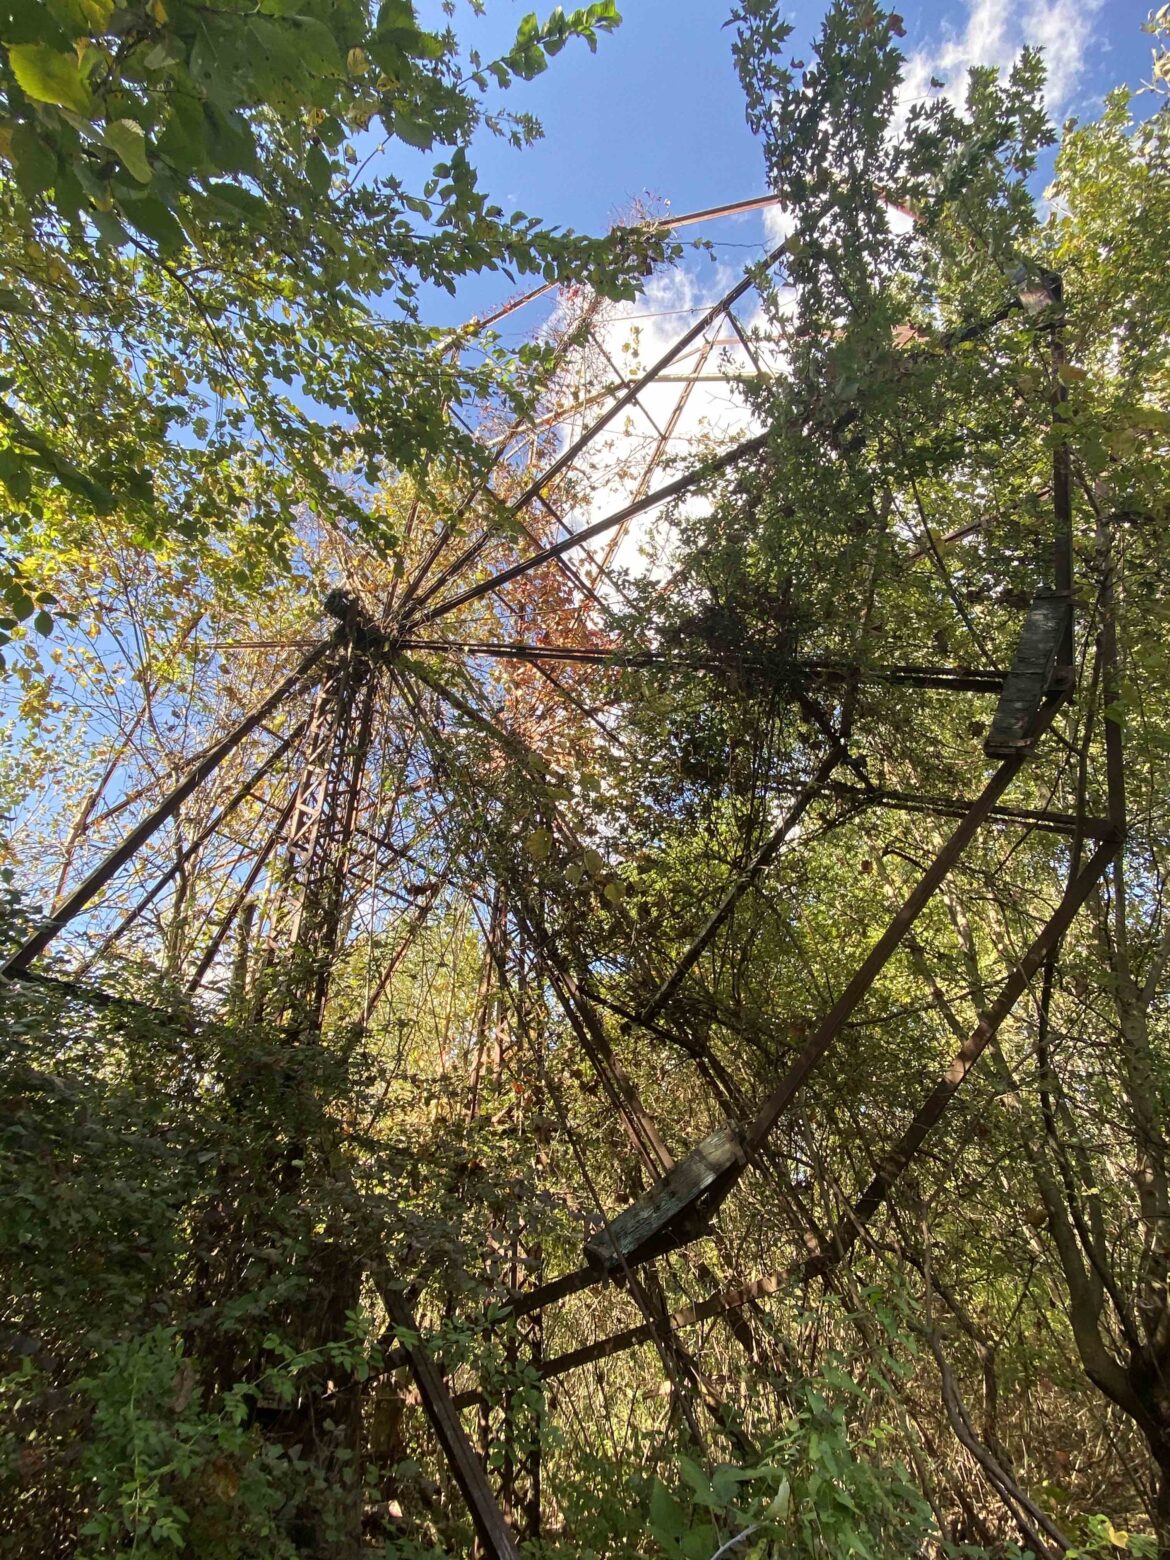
902, 0, 1103, 119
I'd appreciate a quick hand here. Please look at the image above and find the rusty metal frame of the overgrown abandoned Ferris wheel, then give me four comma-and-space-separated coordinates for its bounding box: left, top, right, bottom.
0, 197, 1125, 1557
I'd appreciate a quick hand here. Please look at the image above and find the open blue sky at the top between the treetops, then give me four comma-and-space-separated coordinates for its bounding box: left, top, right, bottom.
408, 0, 1150, 334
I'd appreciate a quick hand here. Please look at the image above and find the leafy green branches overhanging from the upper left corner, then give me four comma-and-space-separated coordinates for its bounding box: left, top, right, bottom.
0, 0, 673, 639
